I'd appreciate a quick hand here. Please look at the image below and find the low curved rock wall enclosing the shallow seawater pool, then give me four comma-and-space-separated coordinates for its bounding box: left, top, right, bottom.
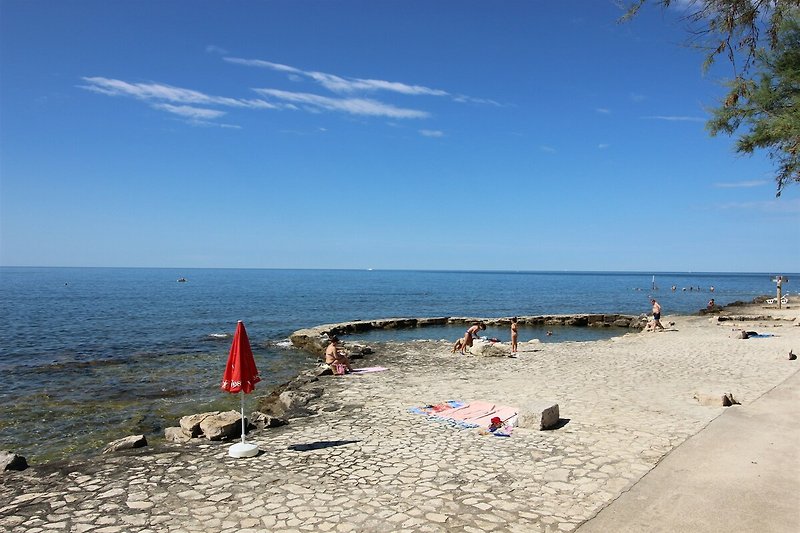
289, 314, 647, 354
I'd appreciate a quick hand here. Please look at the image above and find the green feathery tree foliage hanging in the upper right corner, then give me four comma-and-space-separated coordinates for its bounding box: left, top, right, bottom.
621, 0, 800, 196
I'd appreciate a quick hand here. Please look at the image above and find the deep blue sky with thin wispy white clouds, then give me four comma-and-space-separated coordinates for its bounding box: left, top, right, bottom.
0, 0, 800, 272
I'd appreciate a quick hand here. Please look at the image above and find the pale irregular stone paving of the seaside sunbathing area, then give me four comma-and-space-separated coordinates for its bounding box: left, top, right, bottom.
0, 310, 800, 533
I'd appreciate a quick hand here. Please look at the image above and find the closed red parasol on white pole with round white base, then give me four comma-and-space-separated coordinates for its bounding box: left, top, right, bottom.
222, 320, 261, 457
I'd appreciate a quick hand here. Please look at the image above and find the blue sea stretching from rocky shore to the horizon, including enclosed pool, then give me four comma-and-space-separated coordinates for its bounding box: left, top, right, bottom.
0, 267, 796, 464
